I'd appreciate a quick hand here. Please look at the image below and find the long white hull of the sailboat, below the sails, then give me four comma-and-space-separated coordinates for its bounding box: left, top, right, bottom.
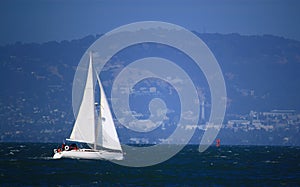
53, 149, 123, 160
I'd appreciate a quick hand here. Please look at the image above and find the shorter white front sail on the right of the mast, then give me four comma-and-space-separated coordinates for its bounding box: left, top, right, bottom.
97, 72, 122, 151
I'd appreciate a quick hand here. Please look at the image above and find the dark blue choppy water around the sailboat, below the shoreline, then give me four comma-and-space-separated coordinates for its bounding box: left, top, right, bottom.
0, 143, 300, 186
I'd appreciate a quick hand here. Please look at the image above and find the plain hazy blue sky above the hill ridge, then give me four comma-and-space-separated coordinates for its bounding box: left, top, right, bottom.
0, 0, 300, 45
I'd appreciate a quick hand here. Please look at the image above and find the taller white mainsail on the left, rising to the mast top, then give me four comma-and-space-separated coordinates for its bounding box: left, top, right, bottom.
69, 52, 96, 143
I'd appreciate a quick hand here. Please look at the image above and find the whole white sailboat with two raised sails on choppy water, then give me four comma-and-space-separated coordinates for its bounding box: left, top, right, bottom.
53, 52, 123, 160
